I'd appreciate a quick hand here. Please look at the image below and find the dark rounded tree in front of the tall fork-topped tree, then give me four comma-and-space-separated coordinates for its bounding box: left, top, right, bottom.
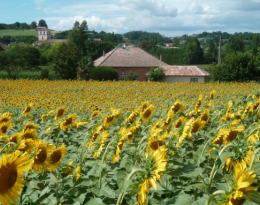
53, 42, 82, 79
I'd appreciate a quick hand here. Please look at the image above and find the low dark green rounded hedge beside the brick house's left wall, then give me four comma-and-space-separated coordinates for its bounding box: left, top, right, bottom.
89, 67, 118, 81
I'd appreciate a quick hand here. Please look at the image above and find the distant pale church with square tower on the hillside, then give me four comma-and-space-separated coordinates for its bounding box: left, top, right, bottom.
33, 27, 68, 47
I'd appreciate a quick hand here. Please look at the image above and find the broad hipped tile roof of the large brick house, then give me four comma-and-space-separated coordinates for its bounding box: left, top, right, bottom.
94, 46, 168, 68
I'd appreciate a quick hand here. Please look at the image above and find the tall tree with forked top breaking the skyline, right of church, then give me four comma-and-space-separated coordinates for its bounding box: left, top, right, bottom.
69, 21, 88, 55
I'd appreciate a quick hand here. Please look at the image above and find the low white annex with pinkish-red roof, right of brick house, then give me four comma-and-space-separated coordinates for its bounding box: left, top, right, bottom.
161, 66, 210, 83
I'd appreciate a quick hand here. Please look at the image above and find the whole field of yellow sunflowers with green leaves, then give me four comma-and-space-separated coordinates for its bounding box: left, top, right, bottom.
0, 80, 260, 205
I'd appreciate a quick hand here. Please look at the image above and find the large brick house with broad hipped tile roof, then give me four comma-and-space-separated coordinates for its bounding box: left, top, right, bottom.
94, 46, 169, 81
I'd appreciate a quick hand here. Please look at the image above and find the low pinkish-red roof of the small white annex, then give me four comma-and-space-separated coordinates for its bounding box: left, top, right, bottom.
162, 66, 210, 76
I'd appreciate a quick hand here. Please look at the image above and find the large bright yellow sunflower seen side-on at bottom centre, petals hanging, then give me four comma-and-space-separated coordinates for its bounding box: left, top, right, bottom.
137, 149, 168, 205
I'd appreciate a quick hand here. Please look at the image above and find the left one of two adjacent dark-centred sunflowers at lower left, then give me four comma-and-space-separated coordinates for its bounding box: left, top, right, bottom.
30, 140, 54, 173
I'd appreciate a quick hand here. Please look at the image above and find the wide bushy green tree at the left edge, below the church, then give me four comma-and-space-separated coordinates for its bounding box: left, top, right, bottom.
0, 45, 40, 79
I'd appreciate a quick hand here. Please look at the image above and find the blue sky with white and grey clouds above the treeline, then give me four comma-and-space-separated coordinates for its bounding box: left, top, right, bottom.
0, 0, 260, 37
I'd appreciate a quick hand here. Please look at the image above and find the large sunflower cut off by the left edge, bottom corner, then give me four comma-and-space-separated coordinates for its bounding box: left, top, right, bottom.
0, 151, 29, 205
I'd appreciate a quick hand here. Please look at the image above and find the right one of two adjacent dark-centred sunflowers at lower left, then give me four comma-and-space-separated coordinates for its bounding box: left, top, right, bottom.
47, 144, 68, 172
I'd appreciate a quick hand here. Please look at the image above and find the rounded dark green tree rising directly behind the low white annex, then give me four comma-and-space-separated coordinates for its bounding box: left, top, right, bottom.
183, 38, 204, 64
